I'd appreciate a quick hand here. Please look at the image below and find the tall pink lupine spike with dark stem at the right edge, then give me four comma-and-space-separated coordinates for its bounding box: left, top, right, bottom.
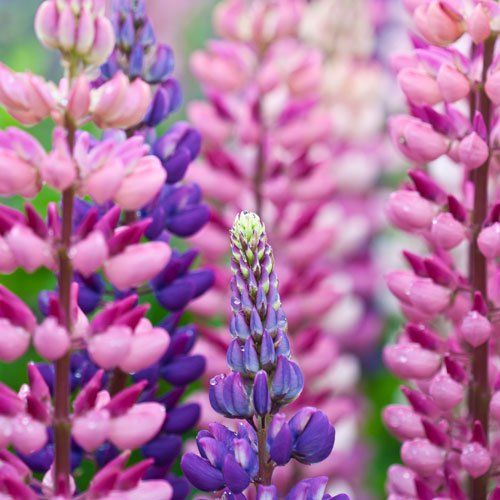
383, 0, 500, 499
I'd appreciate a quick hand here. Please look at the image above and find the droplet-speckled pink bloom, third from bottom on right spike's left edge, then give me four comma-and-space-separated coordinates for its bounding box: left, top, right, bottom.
383, 343, 441, 379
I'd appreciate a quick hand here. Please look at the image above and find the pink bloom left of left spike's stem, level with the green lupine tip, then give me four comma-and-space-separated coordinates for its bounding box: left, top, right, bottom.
5, 224, 55, 273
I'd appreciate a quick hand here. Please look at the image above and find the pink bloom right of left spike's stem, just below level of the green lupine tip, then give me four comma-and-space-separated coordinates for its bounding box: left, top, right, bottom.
104, 241, 171, 290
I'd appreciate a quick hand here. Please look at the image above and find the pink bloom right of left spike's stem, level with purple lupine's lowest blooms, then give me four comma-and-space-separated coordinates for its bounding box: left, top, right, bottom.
109, 403, 166, 450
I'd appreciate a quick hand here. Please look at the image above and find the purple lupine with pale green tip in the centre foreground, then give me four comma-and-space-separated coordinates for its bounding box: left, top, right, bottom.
181, 212, 342, 499
